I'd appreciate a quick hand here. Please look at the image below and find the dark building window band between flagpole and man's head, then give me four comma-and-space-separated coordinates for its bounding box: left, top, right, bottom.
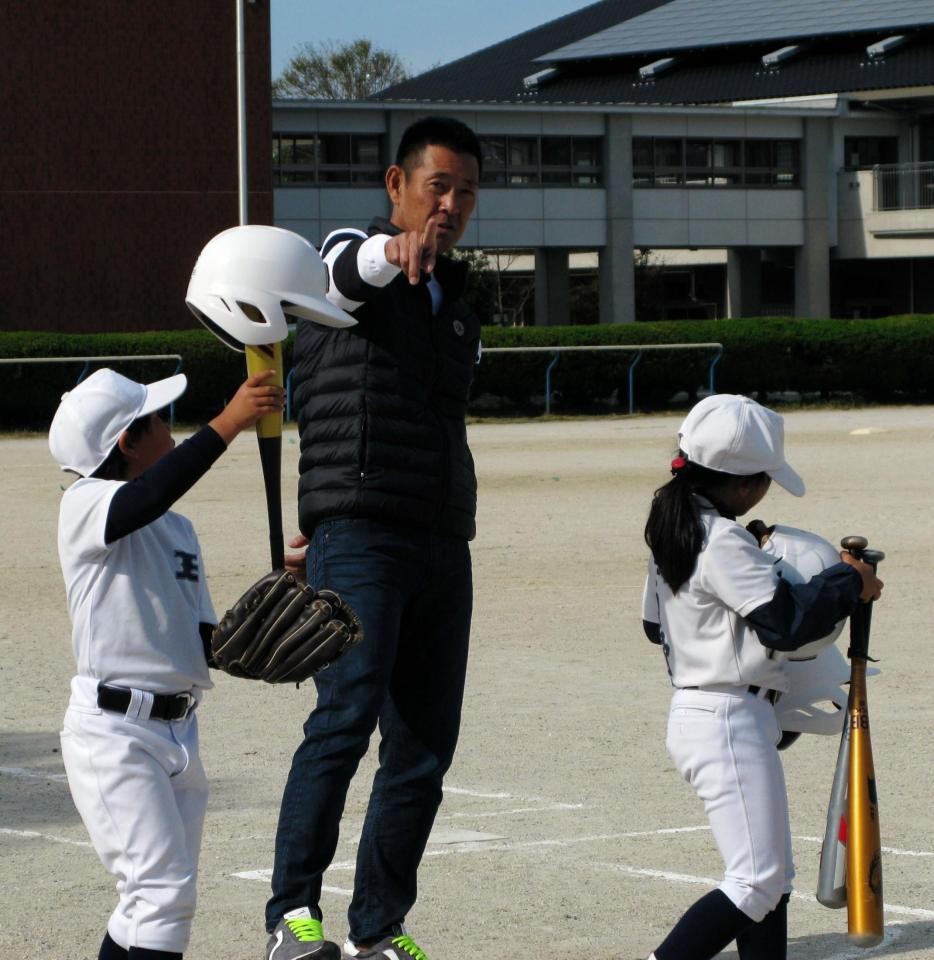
272, 133, 384, 187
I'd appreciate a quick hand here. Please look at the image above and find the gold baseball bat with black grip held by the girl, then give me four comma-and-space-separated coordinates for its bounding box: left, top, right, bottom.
842, 537, 885, 947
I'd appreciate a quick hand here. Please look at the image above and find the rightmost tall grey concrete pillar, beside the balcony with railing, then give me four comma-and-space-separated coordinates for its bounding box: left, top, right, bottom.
795, 117, 836, 317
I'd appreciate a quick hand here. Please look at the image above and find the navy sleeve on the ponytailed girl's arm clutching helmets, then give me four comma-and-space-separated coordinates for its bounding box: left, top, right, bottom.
746, 563, 863, 652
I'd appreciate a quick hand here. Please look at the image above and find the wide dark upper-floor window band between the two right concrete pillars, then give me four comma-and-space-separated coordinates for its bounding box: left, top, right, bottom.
632, 137, 801, 187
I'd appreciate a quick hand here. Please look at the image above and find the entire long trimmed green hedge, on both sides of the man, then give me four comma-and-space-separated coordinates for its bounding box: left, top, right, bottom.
0, 316, 934, 430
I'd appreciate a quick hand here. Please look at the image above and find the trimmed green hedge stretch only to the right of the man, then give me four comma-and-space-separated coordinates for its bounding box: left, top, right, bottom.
474, 316, 934, 413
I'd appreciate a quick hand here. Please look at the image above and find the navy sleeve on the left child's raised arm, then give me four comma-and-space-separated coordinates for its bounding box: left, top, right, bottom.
104, 427, 227, 543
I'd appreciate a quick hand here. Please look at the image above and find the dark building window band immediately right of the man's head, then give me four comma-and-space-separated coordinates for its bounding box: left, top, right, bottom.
480, 137, 603, 187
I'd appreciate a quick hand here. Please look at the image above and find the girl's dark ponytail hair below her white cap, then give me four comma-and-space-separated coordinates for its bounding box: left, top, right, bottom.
645, 450, 765, 593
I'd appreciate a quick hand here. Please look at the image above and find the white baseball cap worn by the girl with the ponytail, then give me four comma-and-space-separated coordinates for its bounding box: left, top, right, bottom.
678, 393, 804, 497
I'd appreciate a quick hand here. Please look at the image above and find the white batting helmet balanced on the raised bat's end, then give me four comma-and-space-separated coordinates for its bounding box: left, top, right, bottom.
185, 224, 357, 351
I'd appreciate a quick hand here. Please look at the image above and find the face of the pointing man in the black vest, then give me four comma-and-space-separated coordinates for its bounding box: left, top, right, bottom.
386, 145, 480, 253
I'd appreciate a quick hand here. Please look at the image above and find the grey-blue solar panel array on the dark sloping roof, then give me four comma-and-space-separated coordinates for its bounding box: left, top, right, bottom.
537, 0, 934, 62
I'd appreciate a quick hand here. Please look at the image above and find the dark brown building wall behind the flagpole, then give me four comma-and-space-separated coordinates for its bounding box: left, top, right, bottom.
0, 0, 272, 332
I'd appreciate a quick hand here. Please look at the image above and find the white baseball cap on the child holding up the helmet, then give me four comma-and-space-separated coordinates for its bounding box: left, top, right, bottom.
49, 367, 188, 477
